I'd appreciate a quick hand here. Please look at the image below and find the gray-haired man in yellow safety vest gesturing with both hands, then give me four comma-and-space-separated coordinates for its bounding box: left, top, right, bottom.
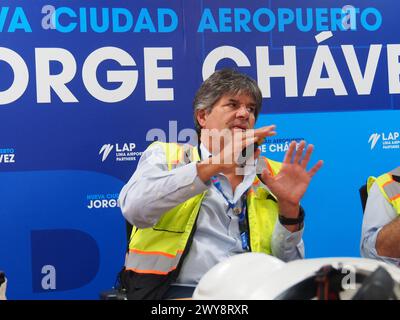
119, 69, 322, 299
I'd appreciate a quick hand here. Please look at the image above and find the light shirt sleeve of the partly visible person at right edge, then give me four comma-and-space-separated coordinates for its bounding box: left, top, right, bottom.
361, 183, 400, 265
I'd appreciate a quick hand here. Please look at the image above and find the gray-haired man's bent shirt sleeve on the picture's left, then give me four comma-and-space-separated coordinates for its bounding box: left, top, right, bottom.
118, 144, 208, 228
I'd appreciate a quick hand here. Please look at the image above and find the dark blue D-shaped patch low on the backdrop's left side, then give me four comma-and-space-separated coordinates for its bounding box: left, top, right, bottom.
31, 229, 100, 292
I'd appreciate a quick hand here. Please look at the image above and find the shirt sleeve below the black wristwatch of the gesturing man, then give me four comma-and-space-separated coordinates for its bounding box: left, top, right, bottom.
271, 219, 304, 262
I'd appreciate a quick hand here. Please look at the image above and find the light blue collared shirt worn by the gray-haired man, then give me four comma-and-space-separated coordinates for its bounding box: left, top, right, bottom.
119, 144, 304, 286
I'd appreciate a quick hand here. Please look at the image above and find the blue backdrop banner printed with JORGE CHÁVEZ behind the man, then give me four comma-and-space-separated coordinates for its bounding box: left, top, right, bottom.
0, 0, 400, 299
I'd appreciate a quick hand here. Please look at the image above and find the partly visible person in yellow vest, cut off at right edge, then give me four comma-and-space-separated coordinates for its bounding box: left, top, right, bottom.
361, 167, 400, 266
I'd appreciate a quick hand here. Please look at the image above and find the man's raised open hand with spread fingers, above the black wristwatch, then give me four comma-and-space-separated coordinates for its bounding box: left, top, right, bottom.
261, 141, 323, 218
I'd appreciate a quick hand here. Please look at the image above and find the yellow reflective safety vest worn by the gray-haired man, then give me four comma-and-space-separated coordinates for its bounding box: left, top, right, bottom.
125, 142, 281, 299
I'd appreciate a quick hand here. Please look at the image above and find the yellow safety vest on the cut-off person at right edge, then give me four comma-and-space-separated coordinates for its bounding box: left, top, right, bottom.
367, 167, 400, 215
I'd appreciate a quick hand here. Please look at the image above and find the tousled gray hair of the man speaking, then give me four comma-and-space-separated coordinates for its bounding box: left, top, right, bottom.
193, 69, 262, 134
